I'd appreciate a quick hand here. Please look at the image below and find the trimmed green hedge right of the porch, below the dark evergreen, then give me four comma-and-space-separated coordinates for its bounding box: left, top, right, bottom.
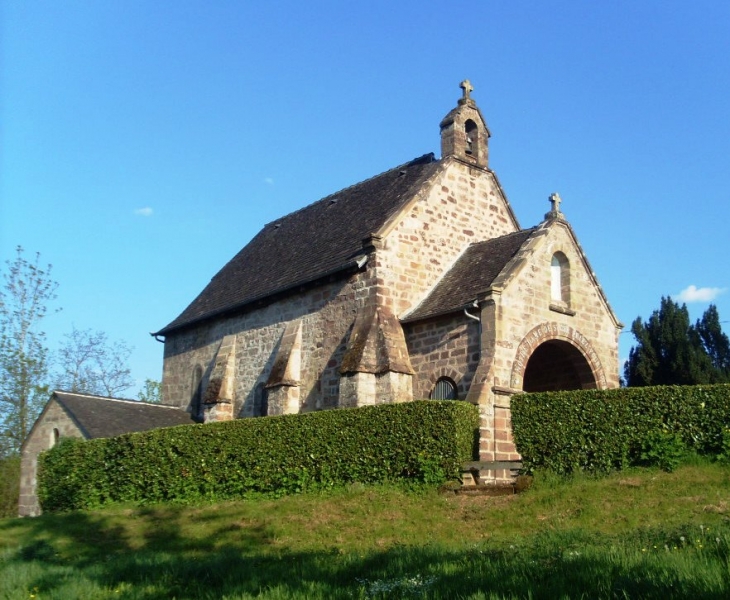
511, 384, 730, 473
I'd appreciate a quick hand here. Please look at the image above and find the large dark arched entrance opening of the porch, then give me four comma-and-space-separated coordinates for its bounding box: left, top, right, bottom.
522, 340, 598, 392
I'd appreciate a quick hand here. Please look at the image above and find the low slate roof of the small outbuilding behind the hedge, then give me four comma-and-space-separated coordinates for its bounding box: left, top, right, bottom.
53, 391, 193, 439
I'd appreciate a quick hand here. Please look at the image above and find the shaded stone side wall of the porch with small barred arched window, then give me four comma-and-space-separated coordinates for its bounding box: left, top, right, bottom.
405, 314, 480, 399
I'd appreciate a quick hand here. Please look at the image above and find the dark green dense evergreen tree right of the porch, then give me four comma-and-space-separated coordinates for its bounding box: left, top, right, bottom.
624, 297, 727, 386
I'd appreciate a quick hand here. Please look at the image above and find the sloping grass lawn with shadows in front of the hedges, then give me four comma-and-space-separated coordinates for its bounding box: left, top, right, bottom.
0, 463, 730, 600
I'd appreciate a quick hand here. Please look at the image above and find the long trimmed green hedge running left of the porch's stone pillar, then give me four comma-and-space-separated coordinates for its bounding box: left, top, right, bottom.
38, 401, 479, 511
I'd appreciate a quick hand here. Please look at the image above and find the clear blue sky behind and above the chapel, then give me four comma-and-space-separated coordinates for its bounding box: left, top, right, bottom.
0, 0, 730, 395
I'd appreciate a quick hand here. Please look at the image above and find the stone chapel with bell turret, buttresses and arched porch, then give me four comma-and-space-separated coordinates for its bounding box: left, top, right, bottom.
153, 81, 622, 474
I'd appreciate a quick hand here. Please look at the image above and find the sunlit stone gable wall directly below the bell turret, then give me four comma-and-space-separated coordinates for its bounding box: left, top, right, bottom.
377, 158, 517, 316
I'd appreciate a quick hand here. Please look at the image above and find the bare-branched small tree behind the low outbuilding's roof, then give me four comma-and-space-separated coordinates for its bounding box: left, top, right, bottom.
54, 327, 134, 398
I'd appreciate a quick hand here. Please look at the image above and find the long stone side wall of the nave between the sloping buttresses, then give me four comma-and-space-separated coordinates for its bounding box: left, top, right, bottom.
162, 271, 374, 418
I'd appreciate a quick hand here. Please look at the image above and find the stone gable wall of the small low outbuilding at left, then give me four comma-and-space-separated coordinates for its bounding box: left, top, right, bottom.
18, 400, 83, 517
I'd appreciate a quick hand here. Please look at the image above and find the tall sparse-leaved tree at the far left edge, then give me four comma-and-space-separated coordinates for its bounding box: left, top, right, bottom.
0, 246, 58, 456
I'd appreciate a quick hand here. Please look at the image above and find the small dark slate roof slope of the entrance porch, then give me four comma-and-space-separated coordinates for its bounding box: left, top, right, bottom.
403, 228, 536, 322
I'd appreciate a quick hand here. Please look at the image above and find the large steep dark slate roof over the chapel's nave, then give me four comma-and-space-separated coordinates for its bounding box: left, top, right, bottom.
154, 154, 441, 335
